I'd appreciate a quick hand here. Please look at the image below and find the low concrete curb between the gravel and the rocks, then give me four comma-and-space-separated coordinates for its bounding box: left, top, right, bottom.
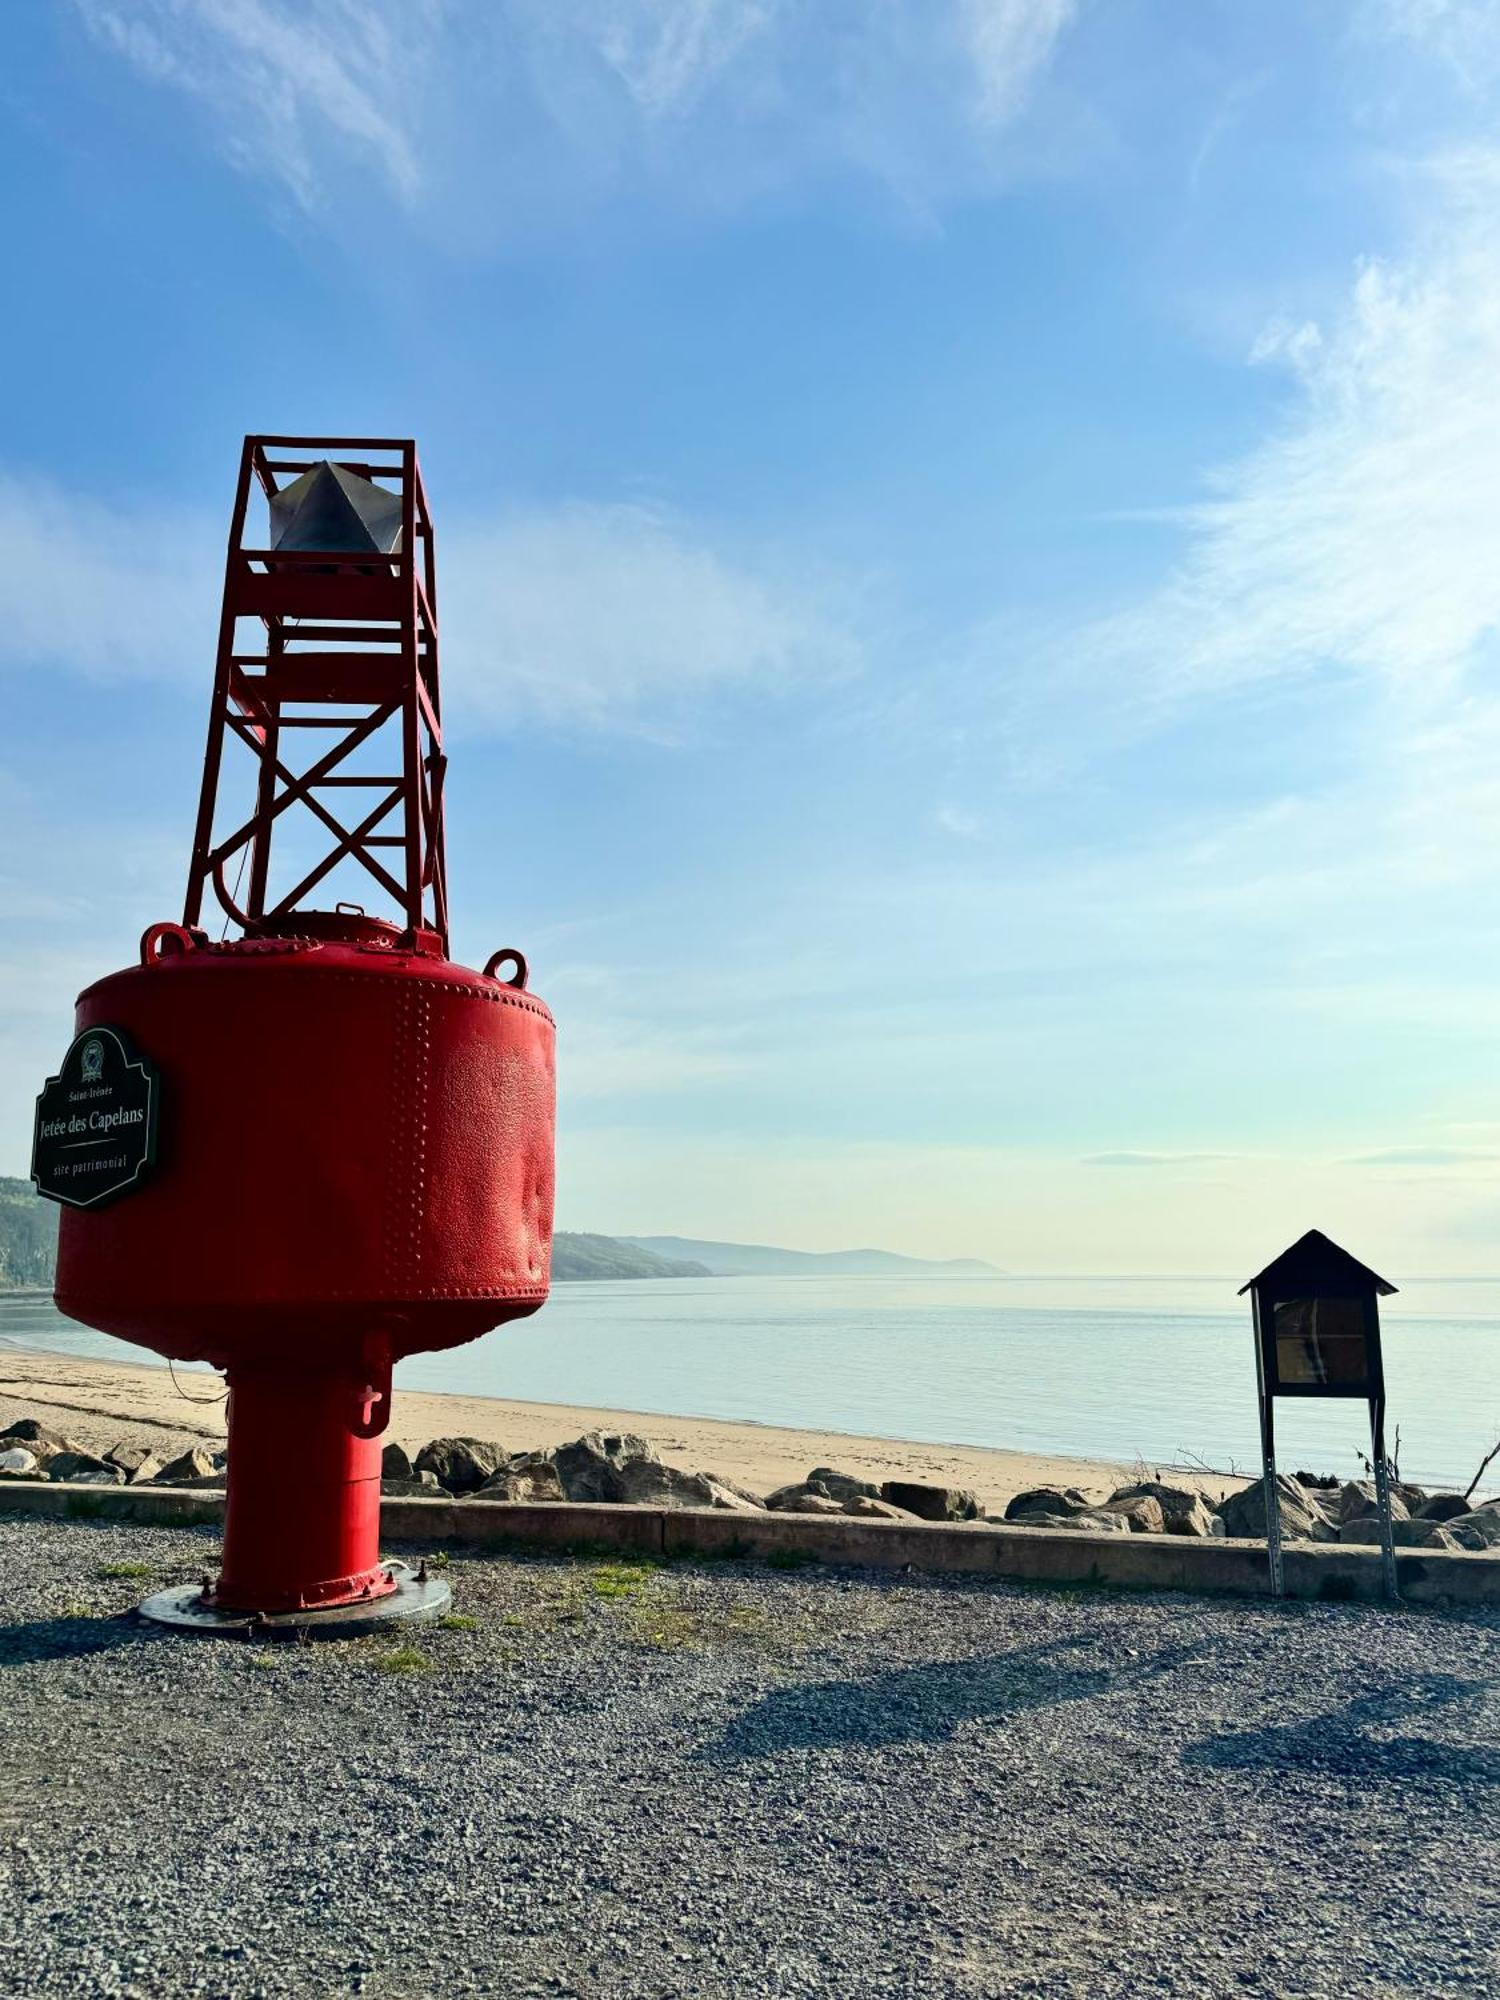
0, 1480, 1500, 1604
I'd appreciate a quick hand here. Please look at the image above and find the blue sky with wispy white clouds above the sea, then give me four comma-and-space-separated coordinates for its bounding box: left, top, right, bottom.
0, 0, 1500, 1272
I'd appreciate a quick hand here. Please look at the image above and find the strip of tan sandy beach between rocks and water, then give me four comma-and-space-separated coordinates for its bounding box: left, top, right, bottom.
0, 1344, 1242, 1514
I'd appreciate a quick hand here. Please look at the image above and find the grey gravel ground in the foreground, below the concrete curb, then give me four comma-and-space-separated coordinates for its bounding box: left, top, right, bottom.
0, 1518, 1500, 2000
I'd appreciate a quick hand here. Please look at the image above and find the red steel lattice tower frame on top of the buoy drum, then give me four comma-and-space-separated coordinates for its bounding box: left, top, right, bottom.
182, 436, 448, 958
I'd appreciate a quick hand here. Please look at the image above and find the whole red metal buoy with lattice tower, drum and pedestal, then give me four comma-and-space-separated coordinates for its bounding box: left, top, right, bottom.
34, 438, 554, 1614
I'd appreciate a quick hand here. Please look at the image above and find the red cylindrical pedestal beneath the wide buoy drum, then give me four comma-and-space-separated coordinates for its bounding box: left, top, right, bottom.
214, 1364, 396, 1612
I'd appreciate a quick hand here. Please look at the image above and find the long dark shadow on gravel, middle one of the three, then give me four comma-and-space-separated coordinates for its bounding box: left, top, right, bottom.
702, 1638, 1202, 1764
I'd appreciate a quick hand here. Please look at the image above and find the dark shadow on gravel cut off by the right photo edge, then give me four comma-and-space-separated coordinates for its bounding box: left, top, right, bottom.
1182, 1674, 1500, 1786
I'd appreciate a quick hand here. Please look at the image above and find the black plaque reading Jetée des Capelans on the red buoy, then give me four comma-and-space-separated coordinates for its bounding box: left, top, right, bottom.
32, 1028, 160, 1208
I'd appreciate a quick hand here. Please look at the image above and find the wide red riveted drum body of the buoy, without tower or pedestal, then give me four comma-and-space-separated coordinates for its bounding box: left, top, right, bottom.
58, 926, 554, 1368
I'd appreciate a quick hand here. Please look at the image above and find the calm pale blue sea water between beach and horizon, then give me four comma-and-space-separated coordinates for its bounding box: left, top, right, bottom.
0, 1278, 1500, 1484
